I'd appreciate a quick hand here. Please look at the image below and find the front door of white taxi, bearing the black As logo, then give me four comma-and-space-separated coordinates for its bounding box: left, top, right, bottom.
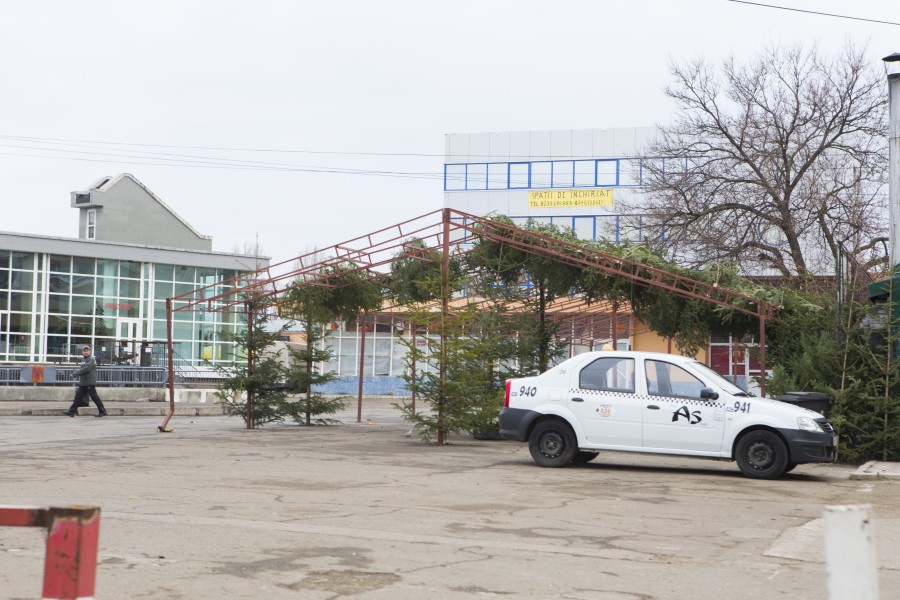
643, 359, 725, 453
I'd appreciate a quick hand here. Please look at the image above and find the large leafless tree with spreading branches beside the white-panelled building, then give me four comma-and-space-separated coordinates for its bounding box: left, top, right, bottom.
628, 46, 887, 278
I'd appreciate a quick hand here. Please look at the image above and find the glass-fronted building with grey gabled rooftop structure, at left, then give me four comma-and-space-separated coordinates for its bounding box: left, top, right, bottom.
0, 173, 269, 366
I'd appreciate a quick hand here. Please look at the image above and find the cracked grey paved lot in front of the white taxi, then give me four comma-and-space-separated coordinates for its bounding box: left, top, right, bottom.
0, 404, 900, 600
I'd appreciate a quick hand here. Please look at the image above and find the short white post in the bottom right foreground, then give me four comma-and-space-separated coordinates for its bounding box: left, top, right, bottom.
825, 505, 878, 600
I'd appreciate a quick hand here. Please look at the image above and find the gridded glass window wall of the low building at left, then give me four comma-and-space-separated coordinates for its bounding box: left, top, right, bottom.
0, 242, 253, 364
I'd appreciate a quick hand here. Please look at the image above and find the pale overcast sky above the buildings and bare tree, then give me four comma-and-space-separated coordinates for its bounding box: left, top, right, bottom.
0, 0, 900, 261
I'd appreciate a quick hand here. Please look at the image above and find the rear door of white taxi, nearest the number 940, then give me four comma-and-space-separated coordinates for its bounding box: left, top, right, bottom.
568, 356, 643, 448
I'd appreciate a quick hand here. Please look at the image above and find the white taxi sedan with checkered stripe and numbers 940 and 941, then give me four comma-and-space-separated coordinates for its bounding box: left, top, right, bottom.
500, 351, 837, 479
